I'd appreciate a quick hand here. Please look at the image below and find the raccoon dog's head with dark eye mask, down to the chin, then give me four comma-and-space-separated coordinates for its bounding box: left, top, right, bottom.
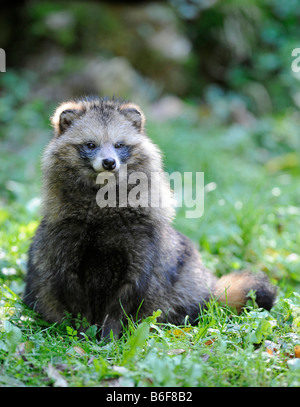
44, 98, 161, 182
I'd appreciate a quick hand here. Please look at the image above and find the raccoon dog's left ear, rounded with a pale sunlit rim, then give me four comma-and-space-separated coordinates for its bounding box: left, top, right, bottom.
51, 102, 85, 136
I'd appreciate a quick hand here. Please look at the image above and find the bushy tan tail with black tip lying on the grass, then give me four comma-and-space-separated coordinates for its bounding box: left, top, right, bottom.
215, 271, 277, 312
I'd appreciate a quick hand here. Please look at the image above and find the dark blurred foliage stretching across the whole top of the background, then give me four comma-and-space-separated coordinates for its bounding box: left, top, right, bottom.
0, 0, 300, 115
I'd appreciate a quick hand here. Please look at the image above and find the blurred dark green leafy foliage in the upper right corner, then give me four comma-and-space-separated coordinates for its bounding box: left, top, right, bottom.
170, 0, 300, 115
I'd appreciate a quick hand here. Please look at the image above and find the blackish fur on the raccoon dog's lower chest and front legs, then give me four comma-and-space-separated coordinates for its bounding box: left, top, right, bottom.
29, 208, 159, 323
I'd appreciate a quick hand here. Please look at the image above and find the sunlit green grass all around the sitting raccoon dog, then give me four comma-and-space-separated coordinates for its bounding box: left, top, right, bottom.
0, 74, 300, 387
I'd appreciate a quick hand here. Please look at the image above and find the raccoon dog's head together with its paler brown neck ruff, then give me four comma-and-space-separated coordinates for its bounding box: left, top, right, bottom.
42, 98, 173, 219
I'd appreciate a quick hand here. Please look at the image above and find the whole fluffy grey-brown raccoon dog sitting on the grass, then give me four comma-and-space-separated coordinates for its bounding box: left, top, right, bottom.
24, 98, 276, 336
